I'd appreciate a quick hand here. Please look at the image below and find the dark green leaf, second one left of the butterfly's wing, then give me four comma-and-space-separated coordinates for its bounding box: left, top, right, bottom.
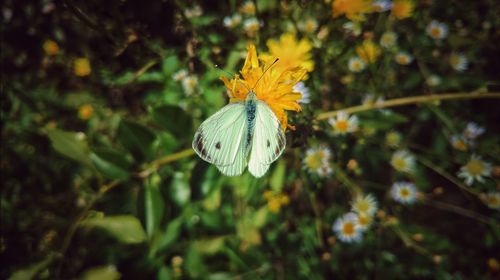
117, 120, 156, 159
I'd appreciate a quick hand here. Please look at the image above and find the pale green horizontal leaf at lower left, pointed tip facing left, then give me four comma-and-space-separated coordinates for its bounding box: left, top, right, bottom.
81, 215, 146, 244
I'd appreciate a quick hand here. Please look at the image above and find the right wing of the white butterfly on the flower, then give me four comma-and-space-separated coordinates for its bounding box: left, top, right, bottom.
248, 100, 286, 177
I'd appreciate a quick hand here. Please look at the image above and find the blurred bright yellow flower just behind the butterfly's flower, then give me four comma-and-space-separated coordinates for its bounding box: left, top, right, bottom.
260, 33, 314, 80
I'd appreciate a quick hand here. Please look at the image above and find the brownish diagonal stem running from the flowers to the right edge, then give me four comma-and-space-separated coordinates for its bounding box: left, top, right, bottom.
316, 92, 500, 120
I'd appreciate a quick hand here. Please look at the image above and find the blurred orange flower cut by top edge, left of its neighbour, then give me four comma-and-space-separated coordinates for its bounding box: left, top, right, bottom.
332, 0, 373, 21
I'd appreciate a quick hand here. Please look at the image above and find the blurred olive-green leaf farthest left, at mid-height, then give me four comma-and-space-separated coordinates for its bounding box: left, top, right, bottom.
47, 129, 91, 166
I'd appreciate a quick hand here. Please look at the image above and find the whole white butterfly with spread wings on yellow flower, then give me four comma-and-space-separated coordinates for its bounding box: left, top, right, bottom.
193, 90, 286, 177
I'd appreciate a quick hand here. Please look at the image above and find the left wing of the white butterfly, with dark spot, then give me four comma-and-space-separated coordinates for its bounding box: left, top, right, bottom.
193, 103, 247, 168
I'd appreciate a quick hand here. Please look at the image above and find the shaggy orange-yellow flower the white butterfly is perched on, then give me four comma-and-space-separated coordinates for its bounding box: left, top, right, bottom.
221, 44, 306, 130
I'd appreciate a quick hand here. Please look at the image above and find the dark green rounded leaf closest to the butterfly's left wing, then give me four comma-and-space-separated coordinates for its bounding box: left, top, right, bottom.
153, 105, 193, 137
